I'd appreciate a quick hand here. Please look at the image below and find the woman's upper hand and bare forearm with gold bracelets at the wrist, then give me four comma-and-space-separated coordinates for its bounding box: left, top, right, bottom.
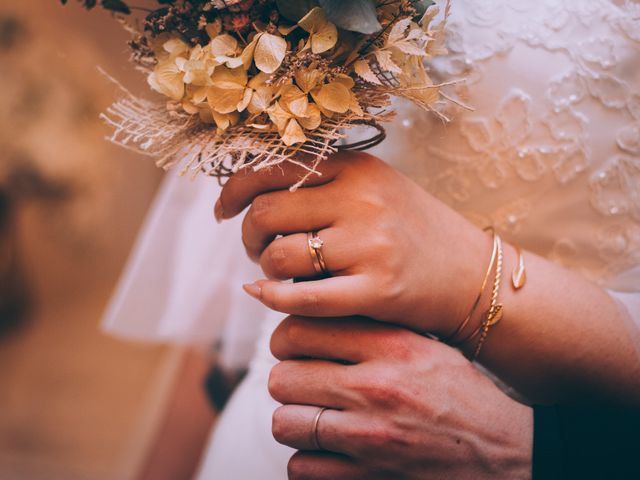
216, 153, 640, 405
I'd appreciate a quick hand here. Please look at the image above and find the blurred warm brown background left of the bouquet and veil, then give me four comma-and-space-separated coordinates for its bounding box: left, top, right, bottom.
0, 0, 190, 480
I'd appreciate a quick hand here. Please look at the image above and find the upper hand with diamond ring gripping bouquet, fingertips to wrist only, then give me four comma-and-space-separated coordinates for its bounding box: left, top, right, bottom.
216, 153, 491, 334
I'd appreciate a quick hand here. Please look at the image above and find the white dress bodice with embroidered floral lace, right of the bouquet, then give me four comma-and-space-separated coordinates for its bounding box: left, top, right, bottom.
382, 0, 640, 280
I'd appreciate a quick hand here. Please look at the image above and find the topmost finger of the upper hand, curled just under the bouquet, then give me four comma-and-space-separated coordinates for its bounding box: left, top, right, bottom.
215, 152, 354, 220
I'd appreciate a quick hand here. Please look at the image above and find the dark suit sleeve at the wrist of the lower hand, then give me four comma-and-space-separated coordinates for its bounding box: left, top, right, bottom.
533, 406, 640, 480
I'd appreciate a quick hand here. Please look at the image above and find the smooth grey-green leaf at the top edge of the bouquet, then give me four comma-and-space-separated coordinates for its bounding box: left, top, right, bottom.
318, 0, 382, 35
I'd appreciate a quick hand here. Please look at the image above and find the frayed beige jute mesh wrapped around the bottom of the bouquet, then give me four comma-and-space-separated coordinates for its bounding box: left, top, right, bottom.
100, 72, 456, 190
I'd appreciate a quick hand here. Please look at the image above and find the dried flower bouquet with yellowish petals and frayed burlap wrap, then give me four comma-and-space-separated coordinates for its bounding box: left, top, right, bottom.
62, 0, 449, 186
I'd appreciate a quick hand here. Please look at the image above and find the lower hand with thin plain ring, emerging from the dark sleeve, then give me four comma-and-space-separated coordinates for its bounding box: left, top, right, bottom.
269, 317, 533, 480
